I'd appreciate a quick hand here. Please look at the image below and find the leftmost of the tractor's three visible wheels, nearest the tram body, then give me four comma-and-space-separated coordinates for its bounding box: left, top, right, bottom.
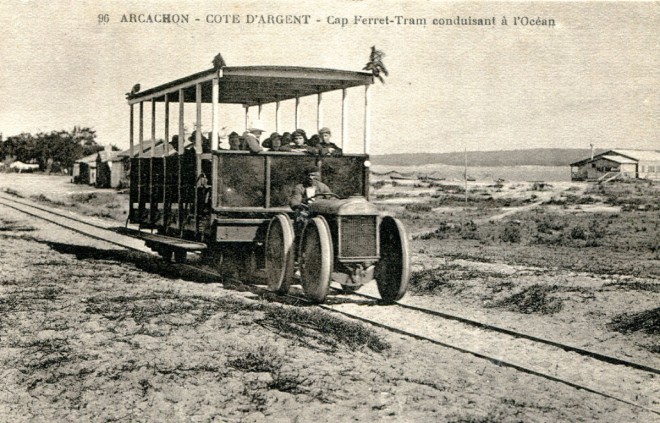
266, 214, 294, 293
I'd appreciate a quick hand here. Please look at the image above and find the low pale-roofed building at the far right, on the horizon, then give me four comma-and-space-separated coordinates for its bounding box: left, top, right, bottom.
571, 149, 660, 181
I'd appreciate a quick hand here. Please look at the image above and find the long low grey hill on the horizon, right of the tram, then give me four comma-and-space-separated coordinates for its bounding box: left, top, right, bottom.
371, 148, 607, 167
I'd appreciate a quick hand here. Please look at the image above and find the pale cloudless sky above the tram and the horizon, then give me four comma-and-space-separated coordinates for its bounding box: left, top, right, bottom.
0, 0, 660, 154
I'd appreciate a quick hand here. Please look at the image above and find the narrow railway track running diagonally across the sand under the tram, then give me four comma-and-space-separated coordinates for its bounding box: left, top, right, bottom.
0, 194, 660, 415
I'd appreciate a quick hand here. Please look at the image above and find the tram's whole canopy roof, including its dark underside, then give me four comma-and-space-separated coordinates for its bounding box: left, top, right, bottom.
128, 66, 373, 106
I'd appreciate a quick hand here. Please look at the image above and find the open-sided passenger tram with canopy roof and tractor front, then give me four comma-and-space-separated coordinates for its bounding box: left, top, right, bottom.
127, 66, 410, 302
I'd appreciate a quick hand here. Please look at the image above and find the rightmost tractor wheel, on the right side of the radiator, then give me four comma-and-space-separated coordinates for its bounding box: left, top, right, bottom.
374, 216, 410, 303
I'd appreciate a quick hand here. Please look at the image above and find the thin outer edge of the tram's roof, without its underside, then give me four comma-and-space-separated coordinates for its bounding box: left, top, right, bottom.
128, 66, 374, 105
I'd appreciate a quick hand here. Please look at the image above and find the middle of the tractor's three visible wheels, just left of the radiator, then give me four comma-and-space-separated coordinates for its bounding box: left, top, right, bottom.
300, 216, 334, 303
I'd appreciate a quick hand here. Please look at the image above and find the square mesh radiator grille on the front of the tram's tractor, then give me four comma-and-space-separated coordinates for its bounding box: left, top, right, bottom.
339, 216, 378, 258
